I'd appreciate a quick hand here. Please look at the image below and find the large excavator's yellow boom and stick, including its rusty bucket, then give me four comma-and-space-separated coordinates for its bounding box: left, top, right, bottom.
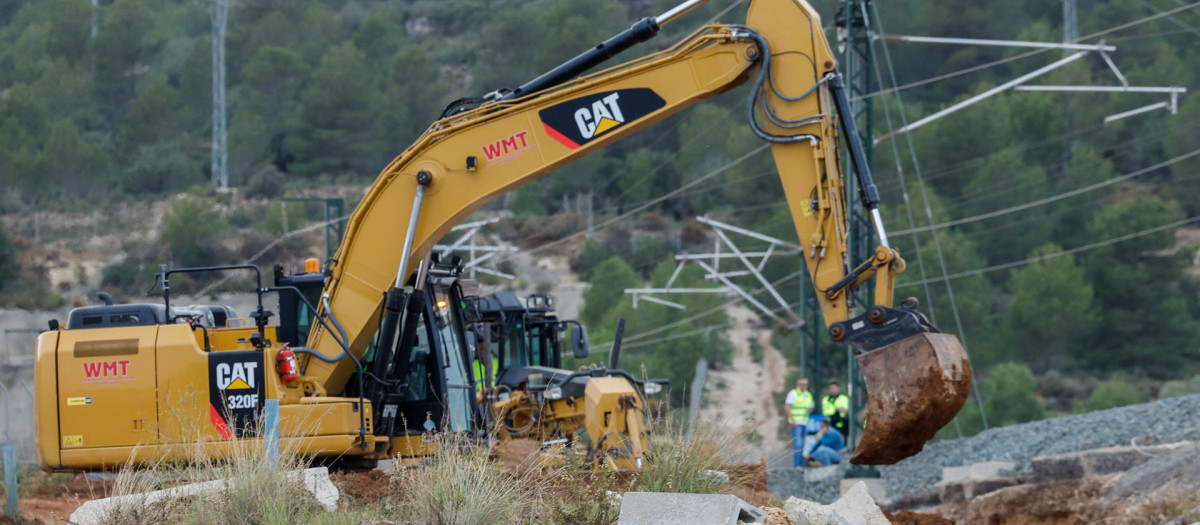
301, 0, 970, 463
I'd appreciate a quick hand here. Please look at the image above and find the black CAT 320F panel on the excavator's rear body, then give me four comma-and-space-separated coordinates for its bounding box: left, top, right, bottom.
209, 350, 265, 439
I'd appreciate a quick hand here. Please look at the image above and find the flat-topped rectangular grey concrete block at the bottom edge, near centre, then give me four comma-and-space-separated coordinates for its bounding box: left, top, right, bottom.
617, 493, 767, 525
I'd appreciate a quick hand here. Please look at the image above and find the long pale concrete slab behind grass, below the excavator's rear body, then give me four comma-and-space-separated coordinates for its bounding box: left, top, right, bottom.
71, 466, 340, 525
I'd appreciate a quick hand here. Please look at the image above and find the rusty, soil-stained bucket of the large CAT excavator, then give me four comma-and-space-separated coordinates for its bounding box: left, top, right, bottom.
850, 333, 971, 465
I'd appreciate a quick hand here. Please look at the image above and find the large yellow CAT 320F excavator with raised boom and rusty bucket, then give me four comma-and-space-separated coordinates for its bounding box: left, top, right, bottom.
35, 0, 971, 470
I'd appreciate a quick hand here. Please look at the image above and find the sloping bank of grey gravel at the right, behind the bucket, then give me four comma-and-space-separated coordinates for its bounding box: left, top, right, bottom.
768, 394, 1200, 503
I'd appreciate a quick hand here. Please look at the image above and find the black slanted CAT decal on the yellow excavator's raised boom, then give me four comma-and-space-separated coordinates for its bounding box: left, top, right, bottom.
538, 88, 667, 150
